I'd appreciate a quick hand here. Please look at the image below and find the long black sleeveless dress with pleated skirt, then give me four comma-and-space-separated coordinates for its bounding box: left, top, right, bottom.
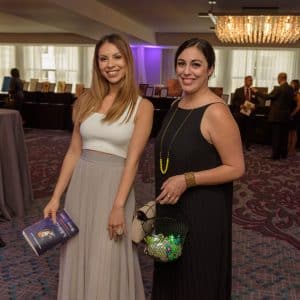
152, 102, 233, 300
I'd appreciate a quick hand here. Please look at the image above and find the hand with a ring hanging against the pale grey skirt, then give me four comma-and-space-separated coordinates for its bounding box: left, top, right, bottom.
107, 206, 126, 241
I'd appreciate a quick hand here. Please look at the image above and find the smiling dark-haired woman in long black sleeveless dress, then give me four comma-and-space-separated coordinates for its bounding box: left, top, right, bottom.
152, 38, 244, 300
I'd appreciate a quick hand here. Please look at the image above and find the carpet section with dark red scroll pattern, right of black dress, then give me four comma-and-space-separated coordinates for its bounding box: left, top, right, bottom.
233, 150, 300, 250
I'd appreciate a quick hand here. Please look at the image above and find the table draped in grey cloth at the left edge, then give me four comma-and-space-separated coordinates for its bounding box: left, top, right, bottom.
0, 109, 33, 220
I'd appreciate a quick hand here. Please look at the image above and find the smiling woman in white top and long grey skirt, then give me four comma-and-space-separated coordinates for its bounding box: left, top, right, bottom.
44, 34, 153, 300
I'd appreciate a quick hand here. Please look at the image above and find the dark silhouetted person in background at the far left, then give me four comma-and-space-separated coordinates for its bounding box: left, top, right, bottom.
8, 68, 24, 113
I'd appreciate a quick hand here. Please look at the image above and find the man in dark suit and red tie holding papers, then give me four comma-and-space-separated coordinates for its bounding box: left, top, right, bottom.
231, 75, 258, 150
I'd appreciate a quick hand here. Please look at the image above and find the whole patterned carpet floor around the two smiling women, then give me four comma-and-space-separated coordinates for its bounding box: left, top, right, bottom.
0, 129, 300, 300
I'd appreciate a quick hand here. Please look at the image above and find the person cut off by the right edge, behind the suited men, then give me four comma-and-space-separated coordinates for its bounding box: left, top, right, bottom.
288, 79, 300, 156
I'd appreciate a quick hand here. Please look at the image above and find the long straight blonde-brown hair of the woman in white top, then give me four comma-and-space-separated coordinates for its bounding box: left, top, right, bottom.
73, 34, 139, 123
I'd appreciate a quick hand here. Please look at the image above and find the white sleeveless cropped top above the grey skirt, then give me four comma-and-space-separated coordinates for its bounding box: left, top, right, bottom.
80, 97, 142, 158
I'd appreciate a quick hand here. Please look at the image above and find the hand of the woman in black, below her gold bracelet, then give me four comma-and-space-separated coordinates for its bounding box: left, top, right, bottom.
156, 174, 186, 204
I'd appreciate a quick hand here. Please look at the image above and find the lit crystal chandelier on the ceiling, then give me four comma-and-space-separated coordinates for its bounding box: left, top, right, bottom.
215, 15, 300, 44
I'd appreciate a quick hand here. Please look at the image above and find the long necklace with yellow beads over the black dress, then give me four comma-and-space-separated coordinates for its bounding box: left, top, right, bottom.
159, 106, 194, 175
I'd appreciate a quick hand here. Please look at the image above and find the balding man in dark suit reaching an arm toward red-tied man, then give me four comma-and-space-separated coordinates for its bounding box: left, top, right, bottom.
255, 73, 294, 160
